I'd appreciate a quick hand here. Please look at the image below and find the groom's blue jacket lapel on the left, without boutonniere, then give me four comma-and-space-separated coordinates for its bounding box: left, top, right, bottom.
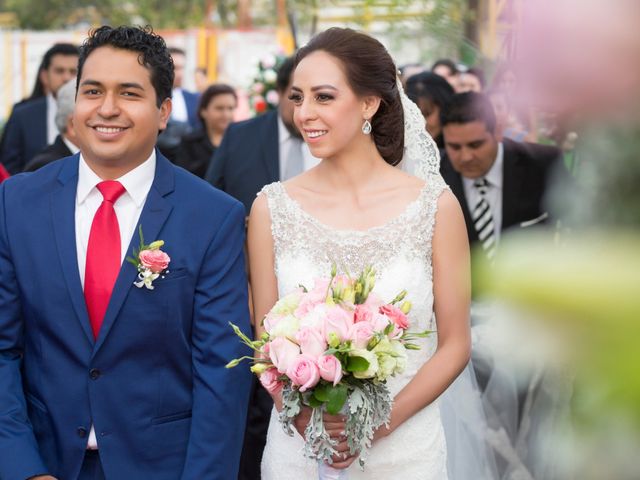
51, 155, 93, 343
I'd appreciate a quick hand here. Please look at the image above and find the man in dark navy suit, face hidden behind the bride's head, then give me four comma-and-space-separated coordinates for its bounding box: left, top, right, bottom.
205, 54, 319, 480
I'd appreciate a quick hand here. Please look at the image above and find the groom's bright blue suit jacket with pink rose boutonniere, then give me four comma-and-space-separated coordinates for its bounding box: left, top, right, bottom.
0, 154, 250, 480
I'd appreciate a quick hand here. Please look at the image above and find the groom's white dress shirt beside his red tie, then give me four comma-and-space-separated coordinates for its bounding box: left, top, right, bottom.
75, 150, 156, 449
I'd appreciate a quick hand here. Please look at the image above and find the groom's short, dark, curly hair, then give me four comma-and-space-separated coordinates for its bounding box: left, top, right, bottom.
76, 25, 174, 108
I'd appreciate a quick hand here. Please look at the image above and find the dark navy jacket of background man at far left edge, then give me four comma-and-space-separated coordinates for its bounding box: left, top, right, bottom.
0, 97, 47, 174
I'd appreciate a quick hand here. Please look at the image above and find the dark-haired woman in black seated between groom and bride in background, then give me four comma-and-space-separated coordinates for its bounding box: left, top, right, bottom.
175, 83, 238, 178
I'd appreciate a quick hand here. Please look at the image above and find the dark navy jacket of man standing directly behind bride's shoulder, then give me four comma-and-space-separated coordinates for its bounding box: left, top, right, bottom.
205, 111, 280, 215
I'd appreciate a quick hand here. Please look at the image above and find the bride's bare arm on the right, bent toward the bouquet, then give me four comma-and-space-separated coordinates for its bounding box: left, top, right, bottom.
377, 190, 471, 436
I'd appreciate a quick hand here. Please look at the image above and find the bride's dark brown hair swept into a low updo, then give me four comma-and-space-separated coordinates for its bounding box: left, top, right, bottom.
295, 27, 404, 165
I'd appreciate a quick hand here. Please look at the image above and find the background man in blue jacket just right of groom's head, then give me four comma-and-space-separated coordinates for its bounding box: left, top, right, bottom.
158, 47, 202, 162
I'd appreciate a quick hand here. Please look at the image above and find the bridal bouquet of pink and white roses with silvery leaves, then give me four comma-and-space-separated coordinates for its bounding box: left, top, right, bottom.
227, 266, 430, 476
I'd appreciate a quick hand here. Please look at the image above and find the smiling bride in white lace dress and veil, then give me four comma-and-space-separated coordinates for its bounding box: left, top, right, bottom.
248, 28, 492, 480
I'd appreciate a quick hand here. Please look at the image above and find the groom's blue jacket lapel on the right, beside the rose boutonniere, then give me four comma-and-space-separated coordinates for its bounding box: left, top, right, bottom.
93, 151, 175, 355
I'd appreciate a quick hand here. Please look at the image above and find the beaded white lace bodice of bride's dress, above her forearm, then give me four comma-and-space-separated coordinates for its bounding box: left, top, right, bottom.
262, 176, 448, 393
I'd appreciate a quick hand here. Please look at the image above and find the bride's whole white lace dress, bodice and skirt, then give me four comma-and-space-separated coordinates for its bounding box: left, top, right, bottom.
262, 176, 448, 480
